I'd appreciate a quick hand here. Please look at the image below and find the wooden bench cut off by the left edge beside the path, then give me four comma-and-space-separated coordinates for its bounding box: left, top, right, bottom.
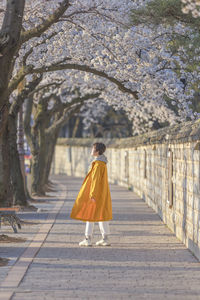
0, 207, 21, 233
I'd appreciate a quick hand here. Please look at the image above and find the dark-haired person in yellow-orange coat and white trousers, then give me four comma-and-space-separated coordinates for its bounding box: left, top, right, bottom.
70, 143, 112, 246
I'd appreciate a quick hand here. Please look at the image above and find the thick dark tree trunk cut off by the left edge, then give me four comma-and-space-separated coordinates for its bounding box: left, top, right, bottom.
0, 0, 25, 206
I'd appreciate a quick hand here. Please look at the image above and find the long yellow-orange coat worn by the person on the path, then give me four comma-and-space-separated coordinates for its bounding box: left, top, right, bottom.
70, 160, 112, 222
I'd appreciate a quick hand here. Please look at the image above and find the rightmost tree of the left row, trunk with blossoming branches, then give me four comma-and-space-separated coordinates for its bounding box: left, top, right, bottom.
25, 79, 100, 195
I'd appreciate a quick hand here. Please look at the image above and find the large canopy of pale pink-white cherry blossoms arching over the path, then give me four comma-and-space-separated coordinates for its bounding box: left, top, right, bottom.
0, 0, 199, 133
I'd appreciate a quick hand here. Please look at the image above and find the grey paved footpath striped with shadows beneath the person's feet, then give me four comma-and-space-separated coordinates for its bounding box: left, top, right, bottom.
0, 176, 200, 300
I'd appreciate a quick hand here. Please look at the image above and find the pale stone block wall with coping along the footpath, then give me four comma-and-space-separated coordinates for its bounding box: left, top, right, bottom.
52, 120, 200, 260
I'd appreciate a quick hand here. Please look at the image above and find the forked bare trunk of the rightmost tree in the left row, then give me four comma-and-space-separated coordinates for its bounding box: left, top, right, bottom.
24, 99, 60, 196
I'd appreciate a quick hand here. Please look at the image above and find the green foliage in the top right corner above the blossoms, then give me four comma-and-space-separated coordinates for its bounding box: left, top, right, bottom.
131, 0, 200, 72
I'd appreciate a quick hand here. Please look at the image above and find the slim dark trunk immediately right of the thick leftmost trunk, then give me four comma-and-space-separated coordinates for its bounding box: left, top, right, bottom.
9, 115, 28, 206
